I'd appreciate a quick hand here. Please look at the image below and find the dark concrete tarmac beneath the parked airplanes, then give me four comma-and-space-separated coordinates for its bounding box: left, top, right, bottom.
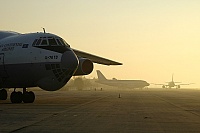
0, 88, 200, 133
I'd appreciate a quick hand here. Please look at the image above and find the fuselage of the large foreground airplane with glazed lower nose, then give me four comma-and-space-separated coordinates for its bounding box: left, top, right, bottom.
0, 33, 79, 91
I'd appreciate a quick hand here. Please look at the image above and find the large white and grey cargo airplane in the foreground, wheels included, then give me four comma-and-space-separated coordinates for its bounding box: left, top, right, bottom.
0, 30, 122, 103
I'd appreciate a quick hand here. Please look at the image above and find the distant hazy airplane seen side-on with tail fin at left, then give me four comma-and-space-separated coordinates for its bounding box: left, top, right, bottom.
96, 70, 150, 88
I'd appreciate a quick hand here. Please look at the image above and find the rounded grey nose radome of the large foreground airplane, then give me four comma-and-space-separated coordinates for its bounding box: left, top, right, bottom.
61, 51, 79, 70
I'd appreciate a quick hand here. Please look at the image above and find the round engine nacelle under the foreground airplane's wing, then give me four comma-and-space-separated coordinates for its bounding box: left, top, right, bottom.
73, 58, 93, 76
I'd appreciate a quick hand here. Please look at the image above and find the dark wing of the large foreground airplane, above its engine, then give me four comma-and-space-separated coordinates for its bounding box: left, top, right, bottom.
72, 49, 122, 65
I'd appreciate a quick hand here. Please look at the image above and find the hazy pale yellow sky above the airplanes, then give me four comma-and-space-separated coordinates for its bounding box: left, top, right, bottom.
0, 0, 200, 87
